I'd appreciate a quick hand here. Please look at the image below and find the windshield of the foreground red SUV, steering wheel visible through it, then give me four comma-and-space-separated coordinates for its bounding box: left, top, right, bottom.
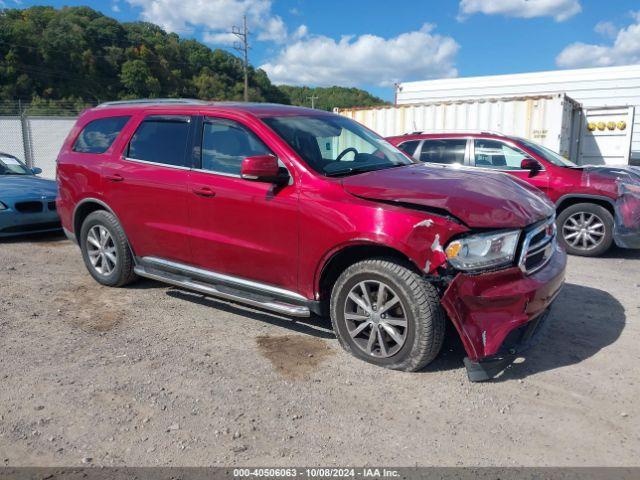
263, 115, 415, 177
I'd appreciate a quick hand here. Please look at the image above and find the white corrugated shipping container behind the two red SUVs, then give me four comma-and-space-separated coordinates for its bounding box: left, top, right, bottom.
335, 93, 581, 160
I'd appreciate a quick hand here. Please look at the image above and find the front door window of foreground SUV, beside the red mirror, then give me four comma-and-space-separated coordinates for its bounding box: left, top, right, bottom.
202, 118, 271, 175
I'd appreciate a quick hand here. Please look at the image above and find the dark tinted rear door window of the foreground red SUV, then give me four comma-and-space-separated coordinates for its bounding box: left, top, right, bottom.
127, 118, 189, 167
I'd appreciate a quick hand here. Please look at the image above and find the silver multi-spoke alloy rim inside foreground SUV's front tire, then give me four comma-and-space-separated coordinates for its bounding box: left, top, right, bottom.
344, 280, 408, 358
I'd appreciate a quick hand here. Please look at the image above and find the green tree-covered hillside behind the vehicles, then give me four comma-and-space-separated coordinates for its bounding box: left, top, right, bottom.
0, 3, 384, 113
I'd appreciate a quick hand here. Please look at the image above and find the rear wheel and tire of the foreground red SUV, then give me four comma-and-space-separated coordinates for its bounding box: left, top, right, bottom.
80, 210, 137, 287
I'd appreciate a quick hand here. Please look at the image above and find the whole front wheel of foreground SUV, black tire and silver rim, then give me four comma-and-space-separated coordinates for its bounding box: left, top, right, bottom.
330, 259, 446, 372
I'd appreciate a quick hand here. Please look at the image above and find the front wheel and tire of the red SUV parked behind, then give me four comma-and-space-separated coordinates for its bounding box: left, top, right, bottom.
556, 203, 613, 257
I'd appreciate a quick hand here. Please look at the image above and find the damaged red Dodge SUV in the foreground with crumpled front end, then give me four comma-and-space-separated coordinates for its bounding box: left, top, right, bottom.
58, 100, 566, 380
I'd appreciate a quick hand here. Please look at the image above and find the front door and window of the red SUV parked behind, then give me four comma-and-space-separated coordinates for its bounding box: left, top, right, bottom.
470, 138, 549, 193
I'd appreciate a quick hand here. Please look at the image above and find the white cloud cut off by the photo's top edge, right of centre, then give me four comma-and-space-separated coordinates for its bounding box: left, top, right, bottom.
459, 0, 582, 22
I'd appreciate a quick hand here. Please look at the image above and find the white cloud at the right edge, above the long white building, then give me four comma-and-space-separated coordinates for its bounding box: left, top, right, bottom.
556, 12, 640, 68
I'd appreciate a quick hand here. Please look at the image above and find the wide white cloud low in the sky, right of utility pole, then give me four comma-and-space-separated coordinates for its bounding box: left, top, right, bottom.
261, 24, 459, 86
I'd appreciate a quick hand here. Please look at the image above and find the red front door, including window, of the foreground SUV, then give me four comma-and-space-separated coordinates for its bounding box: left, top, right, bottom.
189, 117, 298, 291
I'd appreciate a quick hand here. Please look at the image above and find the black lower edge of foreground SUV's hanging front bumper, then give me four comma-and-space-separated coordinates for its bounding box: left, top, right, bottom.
464, 307, 550, 382
